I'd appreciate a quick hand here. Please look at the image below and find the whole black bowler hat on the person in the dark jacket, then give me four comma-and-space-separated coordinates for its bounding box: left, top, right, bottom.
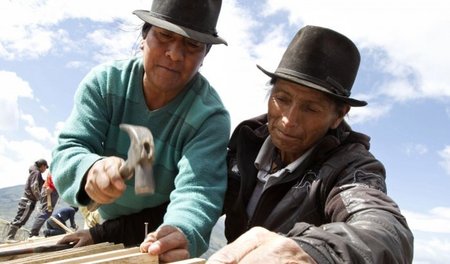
257, 26, 367, 106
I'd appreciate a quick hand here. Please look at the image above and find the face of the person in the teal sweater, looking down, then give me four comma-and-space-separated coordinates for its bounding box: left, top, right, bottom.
142, 26, 206, 94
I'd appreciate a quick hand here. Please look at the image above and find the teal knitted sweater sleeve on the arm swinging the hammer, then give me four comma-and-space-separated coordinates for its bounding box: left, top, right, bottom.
50, 64, 108, 205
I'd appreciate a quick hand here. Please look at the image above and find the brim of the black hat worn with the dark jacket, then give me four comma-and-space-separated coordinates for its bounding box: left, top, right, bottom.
256, 65, 367, 107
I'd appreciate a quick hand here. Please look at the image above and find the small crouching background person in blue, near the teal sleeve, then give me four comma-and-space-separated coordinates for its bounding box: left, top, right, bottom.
44, 206, 78, 237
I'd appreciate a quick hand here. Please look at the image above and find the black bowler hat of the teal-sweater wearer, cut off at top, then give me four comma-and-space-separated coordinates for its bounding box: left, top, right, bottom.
133, 0, 227, 45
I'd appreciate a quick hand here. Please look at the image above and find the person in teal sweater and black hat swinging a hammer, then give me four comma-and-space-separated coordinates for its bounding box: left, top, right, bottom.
51, 0, 230, 262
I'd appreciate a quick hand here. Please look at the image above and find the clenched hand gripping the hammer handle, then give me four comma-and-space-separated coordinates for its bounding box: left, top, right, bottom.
84, 157, 126, 204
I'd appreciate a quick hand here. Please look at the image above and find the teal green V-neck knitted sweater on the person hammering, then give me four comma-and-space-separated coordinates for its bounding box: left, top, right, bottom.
50, 58, 230, 256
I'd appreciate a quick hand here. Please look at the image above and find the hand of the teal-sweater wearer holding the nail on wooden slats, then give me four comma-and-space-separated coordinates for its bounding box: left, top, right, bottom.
140, 225, 189, 262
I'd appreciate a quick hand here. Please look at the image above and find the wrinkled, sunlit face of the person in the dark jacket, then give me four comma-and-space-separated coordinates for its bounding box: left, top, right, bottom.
268, 79, 349, 164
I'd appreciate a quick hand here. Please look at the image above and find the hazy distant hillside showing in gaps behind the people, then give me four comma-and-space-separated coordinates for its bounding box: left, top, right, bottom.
0, 185, 226, 258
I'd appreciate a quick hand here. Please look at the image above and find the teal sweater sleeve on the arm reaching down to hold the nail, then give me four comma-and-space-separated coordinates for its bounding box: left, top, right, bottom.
163, 110, 230, 256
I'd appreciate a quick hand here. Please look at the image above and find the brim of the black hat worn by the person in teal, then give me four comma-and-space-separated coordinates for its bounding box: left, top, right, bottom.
133, 10, 228, 45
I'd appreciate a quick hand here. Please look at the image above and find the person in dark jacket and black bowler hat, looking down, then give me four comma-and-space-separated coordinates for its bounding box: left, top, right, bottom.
208, 26, 413, 264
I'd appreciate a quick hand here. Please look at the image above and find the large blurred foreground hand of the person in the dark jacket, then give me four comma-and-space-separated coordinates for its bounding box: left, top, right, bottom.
207, 227, 316, 264
